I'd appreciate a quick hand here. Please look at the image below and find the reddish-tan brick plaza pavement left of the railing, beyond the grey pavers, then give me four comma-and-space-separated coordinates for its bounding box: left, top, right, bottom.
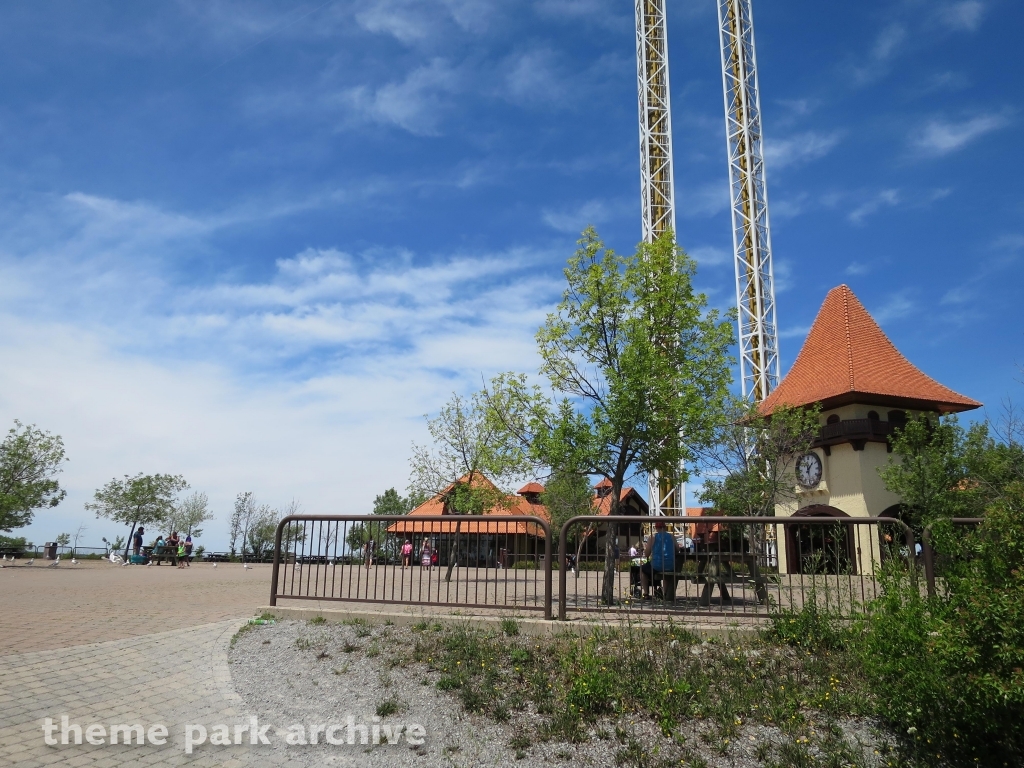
0, 560, 270, 655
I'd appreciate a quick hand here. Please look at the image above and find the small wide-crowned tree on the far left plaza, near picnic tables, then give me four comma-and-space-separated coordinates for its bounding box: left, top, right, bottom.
85, 473, 188, 559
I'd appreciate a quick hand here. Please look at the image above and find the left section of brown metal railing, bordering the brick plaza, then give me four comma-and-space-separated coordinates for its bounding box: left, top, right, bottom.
270, 515, 552, 618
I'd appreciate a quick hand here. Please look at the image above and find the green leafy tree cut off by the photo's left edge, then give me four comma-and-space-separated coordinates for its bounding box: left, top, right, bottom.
0, 419, 67, 531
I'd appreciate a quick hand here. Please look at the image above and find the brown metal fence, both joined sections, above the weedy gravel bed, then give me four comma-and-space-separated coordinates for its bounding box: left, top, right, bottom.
270, 515, 918, 620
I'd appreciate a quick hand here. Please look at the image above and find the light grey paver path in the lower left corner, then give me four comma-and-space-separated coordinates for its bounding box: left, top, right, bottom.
0, 621, 264, 768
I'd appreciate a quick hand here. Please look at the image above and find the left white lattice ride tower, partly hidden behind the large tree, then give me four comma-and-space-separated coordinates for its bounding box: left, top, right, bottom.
636, 0, 686, 515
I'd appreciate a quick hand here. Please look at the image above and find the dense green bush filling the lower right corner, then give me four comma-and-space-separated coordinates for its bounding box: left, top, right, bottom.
860, 503, 1024, 766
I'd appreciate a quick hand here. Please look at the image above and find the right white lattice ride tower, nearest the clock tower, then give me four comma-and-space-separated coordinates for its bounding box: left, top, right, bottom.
718, 0, 779, 402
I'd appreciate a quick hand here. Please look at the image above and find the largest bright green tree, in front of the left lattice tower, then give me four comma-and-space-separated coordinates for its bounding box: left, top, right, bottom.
487, 228, 733, 604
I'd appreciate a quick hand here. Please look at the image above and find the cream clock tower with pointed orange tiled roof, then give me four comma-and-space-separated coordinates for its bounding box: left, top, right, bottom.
761, 286, 981, 572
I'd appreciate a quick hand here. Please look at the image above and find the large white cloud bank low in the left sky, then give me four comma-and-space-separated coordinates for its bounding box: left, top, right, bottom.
0, 195, 561, 549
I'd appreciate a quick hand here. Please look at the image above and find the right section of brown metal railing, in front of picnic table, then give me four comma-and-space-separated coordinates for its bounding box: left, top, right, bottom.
558, 515, 916, 620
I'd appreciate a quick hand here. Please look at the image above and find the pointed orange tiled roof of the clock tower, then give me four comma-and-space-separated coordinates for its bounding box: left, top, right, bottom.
761, 286, 981, 414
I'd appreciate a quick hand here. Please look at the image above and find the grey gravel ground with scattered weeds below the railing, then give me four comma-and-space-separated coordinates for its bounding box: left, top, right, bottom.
228, 621, 881, 768
